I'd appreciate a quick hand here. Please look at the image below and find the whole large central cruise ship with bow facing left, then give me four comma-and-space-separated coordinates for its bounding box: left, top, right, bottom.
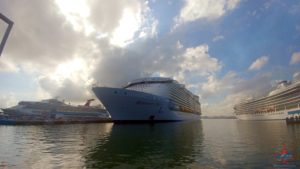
92, 77, 201, 122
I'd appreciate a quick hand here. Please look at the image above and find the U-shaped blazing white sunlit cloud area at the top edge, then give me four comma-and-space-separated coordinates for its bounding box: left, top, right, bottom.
55, 0, 158, 47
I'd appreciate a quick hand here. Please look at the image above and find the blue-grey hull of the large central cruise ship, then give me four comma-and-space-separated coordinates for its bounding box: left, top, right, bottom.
93, 87, 200, 122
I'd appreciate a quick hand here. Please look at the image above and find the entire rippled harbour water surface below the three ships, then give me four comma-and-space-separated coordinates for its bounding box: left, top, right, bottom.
0, 119, 300, 169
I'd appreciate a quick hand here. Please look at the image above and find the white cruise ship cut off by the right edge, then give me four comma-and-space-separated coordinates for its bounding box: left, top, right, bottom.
234, 81, 300, 120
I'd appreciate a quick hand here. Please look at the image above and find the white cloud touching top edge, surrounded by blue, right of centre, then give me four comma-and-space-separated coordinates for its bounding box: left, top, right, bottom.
175, 0, 239, 24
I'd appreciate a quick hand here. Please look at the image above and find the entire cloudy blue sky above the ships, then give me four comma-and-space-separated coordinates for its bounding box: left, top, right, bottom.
0, 0, 300, 116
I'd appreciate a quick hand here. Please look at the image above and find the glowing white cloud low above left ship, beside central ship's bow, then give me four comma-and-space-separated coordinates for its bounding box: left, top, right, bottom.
38, 58, 94, 102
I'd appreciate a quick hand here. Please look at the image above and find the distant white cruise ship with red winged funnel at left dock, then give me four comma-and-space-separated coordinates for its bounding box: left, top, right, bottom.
0, 99, 110, 124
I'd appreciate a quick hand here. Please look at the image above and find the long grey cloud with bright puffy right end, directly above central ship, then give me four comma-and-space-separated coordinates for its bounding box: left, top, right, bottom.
92, 38, 222, 91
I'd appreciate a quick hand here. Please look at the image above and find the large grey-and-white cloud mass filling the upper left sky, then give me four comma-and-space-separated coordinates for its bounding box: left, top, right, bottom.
0, 0, 158, 101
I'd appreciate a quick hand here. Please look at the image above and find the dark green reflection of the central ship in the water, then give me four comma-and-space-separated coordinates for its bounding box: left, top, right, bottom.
87, 121, 203, 168
